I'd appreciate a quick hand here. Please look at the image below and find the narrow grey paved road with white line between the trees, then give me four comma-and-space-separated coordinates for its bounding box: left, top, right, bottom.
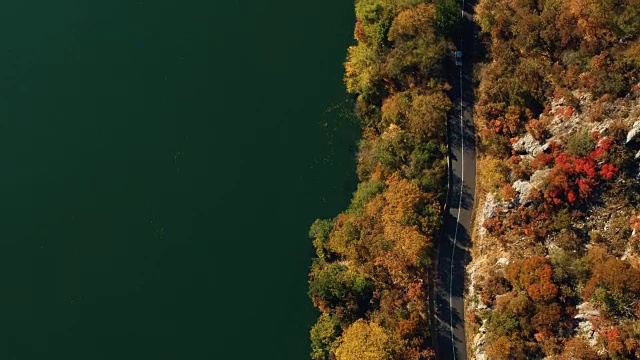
434, 0, 476, 360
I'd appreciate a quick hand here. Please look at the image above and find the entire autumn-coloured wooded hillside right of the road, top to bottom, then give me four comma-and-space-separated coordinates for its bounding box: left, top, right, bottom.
467, 0, 640, 360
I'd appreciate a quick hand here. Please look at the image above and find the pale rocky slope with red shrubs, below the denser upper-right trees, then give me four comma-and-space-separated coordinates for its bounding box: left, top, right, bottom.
467, 91, 640, 359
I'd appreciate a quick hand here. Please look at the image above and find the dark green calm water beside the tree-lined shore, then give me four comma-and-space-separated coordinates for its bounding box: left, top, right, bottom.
0, 0, 357, 360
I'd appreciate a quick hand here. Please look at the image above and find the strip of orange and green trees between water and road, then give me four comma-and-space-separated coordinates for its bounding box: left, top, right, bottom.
309, 0, 460, 360
